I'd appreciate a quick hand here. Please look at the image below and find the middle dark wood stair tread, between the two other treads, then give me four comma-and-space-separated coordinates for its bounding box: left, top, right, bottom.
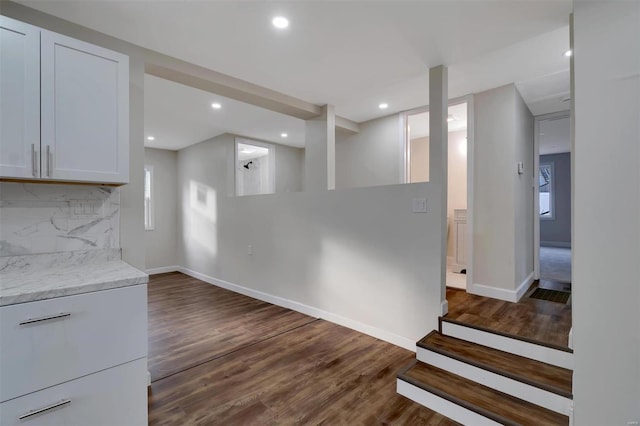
418, 331, 573, 398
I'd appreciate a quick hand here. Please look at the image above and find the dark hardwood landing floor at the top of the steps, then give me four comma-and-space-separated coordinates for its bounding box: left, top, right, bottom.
447, 284, 571, 348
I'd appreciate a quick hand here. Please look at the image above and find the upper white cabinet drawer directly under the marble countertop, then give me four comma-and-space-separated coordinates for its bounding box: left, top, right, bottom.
0, 285, 147, 402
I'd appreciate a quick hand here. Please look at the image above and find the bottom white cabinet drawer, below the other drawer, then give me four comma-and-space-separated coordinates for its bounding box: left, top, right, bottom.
0, 358, 147, 426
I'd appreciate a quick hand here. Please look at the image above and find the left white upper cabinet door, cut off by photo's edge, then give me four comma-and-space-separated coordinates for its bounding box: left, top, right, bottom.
0, 16, 40, 178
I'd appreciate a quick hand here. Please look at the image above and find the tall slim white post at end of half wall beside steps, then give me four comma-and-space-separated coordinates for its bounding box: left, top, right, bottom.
429, 65, 449, 308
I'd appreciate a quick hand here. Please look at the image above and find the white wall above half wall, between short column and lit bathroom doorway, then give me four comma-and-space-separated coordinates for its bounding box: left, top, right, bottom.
336, 114, 404, 188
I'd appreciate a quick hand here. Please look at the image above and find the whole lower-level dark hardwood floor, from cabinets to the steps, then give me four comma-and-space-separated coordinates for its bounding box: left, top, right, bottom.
149, 273, 456, 425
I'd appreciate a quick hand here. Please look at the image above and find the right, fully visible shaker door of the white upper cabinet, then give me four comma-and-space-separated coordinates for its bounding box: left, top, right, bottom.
41, 30, 129, 183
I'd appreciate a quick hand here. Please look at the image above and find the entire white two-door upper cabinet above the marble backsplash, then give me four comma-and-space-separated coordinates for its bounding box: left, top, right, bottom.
0, 17, 129, 184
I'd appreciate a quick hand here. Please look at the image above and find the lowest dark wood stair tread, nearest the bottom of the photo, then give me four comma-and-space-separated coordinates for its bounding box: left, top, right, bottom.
398, 361, 569, 426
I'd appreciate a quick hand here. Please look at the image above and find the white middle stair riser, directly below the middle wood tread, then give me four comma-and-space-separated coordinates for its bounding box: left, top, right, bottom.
416, 347, 571, 416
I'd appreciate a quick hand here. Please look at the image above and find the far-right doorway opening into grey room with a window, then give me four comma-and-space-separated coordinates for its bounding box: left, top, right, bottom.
534, 111, 571, 291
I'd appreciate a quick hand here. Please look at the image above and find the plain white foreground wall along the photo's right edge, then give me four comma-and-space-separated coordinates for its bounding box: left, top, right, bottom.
572, 1, 640, 426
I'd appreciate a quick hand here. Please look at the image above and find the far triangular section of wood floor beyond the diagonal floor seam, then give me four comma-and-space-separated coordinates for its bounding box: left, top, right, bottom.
148, 272, 314, 381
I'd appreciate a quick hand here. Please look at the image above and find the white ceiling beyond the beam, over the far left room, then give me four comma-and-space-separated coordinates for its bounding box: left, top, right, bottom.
144, 74, 305, 151
